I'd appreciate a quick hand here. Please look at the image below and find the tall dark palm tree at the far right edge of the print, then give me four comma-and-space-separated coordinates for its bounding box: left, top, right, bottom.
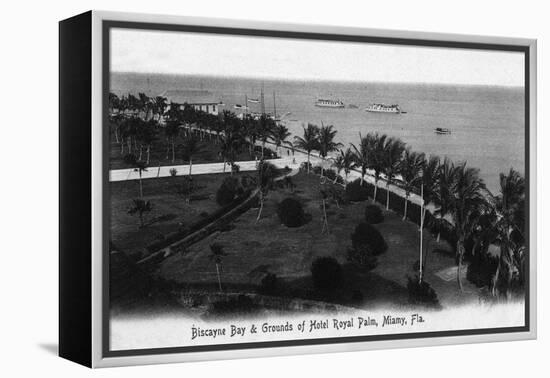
493, 169, 525, 297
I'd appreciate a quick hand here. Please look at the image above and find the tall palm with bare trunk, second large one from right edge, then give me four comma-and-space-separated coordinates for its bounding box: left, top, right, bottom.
450, 163, 486, 291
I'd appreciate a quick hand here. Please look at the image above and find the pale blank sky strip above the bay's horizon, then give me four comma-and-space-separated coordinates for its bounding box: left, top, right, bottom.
110, 29, 524, 86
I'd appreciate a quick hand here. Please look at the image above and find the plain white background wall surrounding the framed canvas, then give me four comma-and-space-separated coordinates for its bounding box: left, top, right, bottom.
0, 0, 550, 378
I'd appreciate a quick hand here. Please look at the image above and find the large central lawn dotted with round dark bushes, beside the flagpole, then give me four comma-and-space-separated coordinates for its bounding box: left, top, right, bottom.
158, 173, 478, 307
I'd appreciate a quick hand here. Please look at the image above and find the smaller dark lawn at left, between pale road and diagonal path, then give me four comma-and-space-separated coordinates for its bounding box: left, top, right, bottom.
109, 173, 254, 259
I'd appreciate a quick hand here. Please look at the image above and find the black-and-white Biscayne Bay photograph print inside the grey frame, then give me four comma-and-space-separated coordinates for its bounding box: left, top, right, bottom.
103, 22, 530, 356
